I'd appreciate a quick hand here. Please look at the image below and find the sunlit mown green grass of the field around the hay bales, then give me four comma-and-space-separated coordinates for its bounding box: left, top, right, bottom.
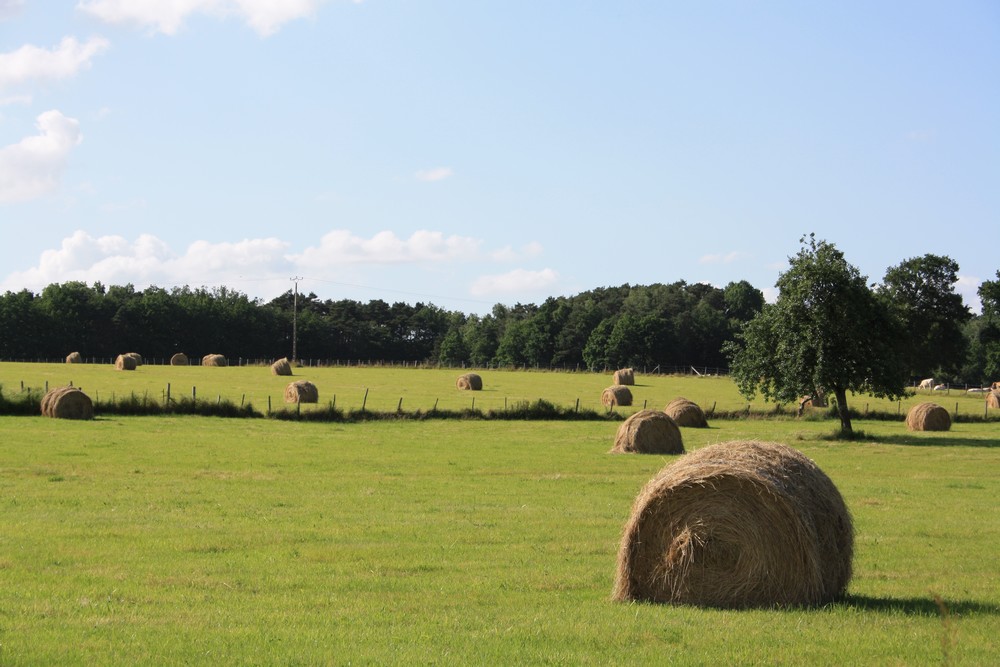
0, 364, 1000, 665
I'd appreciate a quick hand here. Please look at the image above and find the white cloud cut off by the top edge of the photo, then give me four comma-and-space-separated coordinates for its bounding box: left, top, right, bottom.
77, 0, 325, 37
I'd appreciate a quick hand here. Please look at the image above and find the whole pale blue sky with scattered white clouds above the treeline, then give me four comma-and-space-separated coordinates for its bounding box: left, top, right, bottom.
0, 0, 1000, 313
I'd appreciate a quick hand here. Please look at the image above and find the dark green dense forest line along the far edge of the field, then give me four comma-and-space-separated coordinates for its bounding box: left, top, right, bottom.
0, 255, 1000, 384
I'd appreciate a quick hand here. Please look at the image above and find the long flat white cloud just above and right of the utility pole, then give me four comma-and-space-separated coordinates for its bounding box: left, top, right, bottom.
293, 229, 481, 270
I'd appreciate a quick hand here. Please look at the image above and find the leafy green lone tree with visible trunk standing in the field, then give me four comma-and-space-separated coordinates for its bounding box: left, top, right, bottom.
725, 234, 906, 437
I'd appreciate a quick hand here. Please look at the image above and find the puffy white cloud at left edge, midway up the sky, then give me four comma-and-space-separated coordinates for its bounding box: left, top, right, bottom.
0, 111, 83, 203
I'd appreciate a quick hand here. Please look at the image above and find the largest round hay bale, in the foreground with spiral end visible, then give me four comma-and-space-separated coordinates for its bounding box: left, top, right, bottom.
613, 441, 854, 608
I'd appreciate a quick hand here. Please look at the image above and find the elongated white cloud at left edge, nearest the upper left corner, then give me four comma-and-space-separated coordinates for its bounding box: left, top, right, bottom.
0, 37, 110, 89
